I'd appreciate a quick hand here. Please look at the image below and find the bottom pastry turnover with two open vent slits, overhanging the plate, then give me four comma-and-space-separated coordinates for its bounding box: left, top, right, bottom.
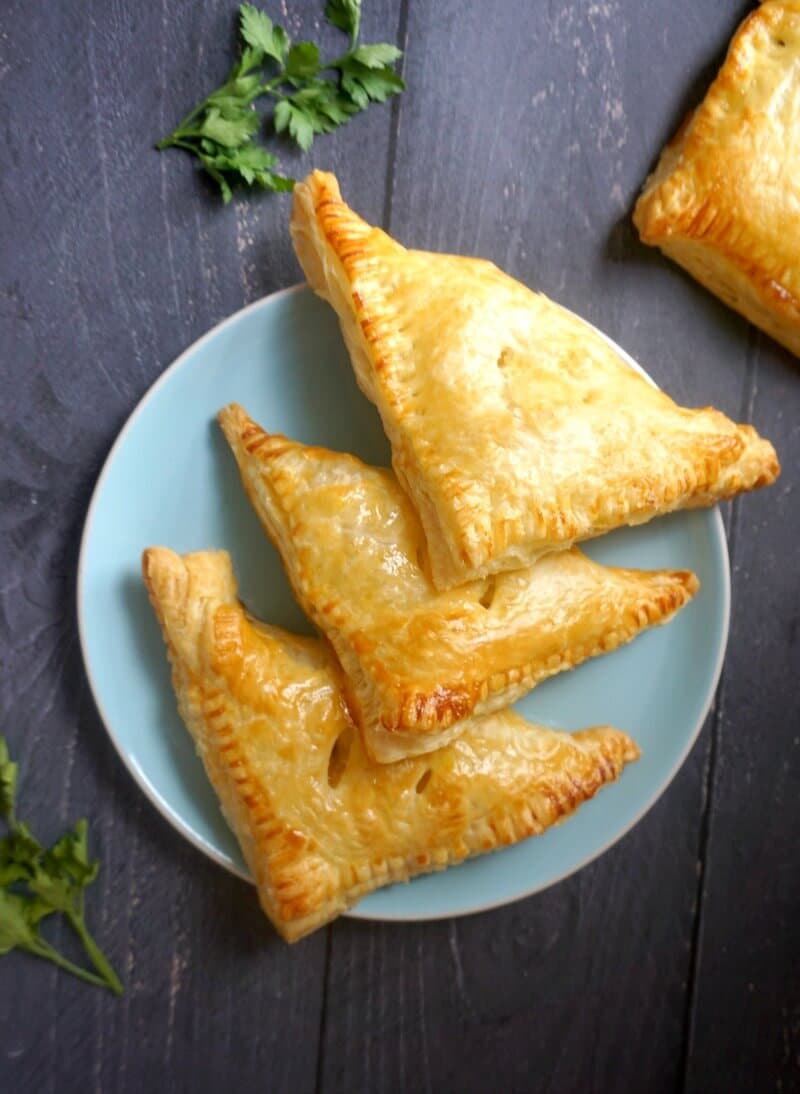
143, 548, 638, 942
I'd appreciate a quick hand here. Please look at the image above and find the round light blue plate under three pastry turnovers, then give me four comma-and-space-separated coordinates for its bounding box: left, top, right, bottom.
78, 288, 730, 919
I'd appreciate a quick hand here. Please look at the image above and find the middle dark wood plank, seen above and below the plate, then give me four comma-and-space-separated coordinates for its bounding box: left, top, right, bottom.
322, 0, 770, 1091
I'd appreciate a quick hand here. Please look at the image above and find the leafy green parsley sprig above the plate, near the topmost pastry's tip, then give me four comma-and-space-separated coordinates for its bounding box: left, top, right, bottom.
155, 0, 405, 203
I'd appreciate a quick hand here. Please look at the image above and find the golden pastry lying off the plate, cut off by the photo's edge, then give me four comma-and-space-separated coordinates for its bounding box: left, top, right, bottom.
634, 0, 800, 354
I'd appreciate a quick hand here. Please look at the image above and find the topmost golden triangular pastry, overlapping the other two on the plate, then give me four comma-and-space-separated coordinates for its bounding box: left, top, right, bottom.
291, 172, 779, 589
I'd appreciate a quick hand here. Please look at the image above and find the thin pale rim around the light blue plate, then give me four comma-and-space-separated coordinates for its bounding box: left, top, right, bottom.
76, 282, 731, 923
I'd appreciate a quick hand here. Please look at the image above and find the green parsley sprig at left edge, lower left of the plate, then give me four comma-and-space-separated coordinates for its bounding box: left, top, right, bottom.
0, 736, 123, 994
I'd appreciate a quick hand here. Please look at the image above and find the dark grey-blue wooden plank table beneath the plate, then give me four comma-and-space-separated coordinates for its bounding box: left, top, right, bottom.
0, 0, 800, 1094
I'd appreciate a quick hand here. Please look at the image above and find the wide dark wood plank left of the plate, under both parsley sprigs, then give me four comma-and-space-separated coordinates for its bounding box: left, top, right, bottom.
0, 0, 397, 1094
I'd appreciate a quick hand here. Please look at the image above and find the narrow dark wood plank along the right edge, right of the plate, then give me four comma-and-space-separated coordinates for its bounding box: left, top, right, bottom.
686, 335, 800, 1094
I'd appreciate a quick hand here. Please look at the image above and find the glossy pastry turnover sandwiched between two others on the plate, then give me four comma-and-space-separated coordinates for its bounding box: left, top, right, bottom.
220, 405, 697, 763
